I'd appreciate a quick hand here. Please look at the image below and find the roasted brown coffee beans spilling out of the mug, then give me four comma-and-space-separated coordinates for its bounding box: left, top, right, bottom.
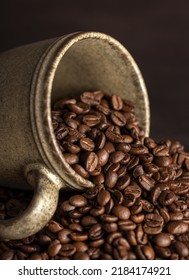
0, 91, 189, 260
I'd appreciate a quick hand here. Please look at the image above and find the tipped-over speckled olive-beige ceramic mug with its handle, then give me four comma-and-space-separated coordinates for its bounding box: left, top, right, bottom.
0, 32, 150, 240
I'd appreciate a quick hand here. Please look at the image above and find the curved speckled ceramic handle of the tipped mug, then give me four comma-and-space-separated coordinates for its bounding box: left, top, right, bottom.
0, 163, 64, 240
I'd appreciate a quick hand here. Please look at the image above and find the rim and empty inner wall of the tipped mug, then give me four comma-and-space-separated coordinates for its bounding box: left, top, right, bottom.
33, 32, 149, 189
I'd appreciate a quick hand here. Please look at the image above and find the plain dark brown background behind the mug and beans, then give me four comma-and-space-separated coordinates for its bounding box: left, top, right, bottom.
0, 0, 189, 150
